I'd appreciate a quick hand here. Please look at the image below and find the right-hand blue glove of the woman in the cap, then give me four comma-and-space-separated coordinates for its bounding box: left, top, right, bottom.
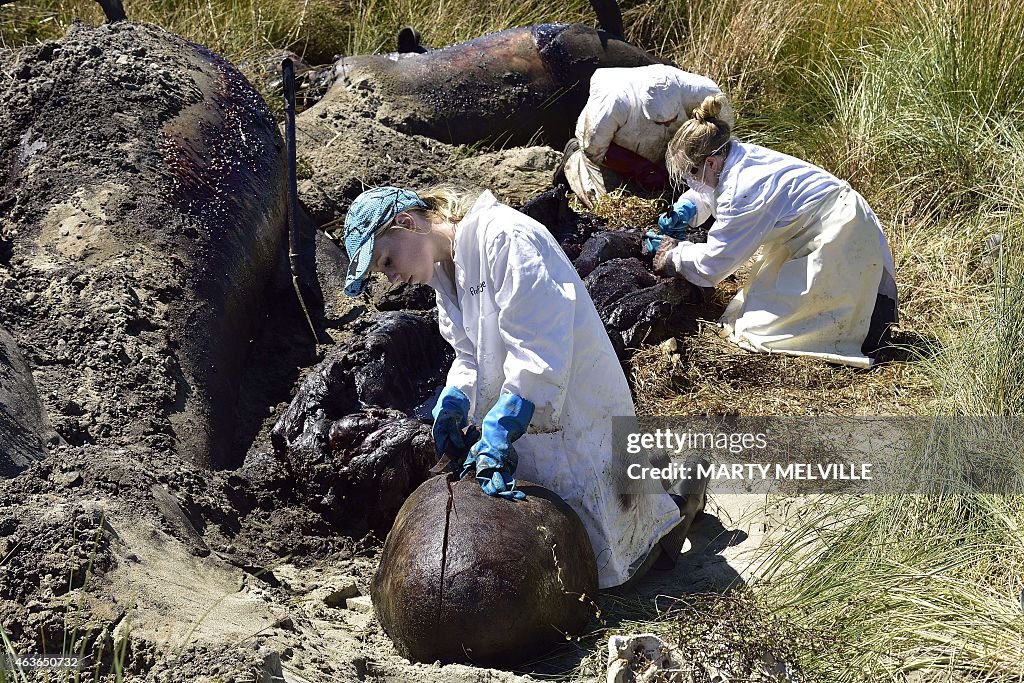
462, 393, 534, 501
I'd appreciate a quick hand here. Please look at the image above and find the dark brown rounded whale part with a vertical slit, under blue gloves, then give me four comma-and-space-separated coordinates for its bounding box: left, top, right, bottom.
371, 476, 598, 666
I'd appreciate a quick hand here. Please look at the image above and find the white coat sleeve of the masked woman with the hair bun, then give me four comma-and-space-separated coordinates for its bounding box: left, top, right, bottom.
669, 212, 771, 287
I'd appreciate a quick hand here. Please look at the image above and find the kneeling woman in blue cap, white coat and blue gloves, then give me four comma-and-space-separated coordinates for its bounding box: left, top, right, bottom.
345, 187, 681, 588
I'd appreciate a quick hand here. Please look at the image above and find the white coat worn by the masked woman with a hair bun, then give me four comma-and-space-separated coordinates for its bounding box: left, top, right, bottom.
670, 140, 897, 368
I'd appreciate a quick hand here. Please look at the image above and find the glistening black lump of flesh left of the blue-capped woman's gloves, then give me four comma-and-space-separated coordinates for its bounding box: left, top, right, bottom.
271, 311, 454, 530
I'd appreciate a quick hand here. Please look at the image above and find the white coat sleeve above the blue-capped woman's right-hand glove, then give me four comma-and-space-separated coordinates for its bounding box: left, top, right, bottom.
487, 230, 575, 430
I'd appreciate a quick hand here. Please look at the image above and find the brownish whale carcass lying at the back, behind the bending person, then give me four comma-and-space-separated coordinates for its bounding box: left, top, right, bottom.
325, 24, 662, 148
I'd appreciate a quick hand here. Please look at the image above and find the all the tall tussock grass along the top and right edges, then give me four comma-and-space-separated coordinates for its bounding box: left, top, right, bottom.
0, 0, 1024, 682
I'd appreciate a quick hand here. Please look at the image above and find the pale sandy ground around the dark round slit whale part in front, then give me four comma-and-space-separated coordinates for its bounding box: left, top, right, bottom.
64, 495, 786, 683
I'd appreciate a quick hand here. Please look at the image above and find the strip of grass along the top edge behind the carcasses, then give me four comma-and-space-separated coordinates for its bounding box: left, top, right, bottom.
0, 0, 596, 63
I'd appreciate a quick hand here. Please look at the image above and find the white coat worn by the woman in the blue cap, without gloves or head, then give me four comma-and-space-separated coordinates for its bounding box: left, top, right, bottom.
430, 191, 680, 588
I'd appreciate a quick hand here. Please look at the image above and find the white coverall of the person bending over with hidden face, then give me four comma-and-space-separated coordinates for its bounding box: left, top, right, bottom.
564, 65, 734, 202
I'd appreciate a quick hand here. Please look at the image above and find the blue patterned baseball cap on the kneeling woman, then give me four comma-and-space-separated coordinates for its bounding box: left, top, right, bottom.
345, 186, 427, 296
